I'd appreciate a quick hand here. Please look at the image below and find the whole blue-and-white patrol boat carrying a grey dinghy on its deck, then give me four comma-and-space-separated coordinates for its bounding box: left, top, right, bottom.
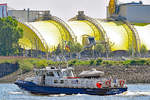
15, 67, 127, 95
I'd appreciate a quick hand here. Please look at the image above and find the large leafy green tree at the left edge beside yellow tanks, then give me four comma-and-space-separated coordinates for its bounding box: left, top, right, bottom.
0, 17, 23, 56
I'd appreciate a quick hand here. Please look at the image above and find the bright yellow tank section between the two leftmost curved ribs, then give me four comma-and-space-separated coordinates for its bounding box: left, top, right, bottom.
28, 20, 72, 51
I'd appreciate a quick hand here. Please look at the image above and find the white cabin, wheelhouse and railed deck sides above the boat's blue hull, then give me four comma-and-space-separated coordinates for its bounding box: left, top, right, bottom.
25, 67, 126, 89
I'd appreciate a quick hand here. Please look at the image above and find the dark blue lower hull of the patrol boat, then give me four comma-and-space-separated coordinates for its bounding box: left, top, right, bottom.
15, 80, 127, 95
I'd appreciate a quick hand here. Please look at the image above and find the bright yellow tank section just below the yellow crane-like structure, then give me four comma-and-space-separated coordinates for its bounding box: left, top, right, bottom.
97, 20, 130, 51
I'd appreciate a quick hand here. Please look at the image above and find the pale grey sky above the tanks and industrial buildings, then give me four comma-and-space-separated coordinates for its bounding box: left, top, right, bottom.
0, 0, 150, 20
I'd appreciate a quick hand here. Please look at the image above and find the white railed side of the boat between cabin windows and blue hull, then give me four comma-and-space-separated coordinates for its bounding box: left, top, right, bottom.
36, 77, 126, 88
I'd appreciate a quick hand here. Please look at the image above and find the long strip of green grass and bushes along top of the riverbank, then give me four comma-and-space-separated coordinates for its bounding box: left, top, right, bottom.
0, 58, 150, 72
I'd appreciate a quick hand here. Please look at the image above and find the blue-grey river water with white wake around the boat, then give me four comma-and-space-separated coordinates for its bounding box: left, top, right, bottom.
0, 84, 150, 100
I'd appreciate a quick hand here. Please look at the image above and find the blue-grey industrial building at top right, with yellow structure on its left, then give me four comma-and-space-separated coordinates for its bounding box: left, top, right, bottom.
107, 0, 150, 23
